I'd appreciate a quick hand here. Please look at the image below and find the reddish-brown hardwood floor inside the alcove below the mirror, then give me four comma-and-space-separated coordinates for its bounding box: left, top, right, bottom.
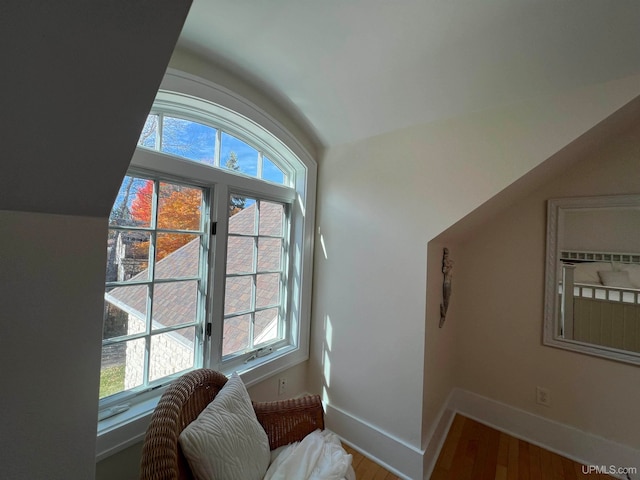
430, 415, 613, 480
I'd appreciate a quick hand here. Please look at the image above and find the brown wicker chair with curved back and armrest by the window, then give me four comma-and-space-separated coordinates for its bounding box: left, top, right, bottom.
140, 369, 324, 480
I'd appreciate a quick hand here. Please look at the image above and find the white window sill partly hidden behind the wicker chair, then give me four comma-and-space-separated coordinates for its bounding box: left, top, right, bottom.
96, 347, 308, 462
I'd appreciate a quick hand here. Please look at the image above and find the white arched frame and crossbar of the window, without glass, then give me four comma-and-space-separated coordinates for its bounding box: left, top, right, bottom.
96, 69, 317, 460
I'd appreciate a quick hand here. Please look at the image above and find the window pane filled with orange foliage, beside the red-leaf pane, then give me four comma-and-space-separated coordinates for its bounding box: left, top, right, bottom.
158, 182, 202, 231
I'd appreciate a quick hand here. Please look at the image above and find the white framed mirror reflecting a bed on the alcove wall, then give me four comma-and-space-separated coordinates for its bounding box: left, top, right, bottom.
543, 195, 640, 365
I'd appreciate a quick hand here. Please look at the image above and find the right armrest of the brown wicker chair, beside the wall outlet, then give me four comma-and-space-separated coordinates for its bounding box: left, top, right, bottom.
252, 395, 324, 450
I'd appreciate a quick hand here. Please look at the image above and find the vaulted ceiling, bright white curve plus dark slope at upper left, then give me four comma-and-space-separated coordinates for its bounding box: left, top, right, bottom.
5, 0, 640, 215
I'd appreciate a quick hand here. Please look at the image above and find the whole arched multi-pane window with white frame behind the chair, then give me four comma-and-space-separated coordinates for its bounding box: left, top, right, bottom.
98, 72, 316, 456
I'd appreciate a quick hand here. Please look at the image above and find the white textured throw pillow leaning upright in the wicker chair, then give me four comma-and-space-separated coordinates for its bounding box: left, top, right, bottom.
179, 373, 270, 480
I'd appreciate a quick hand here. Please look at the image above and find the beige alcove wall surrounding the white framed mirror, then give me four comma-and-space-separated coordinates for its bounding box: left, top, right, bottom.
448, 118, 640, 449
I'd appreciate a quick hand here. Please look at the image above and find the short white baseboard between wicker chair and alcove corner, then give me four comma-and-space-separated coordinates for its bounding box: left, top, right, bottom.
325, 404, 424, 480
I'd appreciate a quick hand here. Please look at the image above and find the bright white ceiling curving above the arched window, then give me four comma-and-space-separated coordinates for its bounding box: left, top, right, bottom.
179, 0, 640, 146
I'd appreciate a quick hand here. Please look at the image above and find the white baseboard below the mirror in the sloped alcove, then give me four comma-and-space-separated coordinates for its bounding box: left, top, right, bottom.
444, 388, 640, 480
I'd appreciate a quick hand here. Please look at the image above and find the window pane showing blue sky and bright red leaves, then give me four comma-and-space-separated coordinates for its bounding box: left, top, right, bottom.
109, 176, 153, 228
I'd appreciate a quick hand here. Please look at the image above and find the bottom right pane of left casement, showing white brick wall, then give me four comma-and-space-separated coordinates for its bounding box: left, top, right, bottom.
149, 327, 195, 382
